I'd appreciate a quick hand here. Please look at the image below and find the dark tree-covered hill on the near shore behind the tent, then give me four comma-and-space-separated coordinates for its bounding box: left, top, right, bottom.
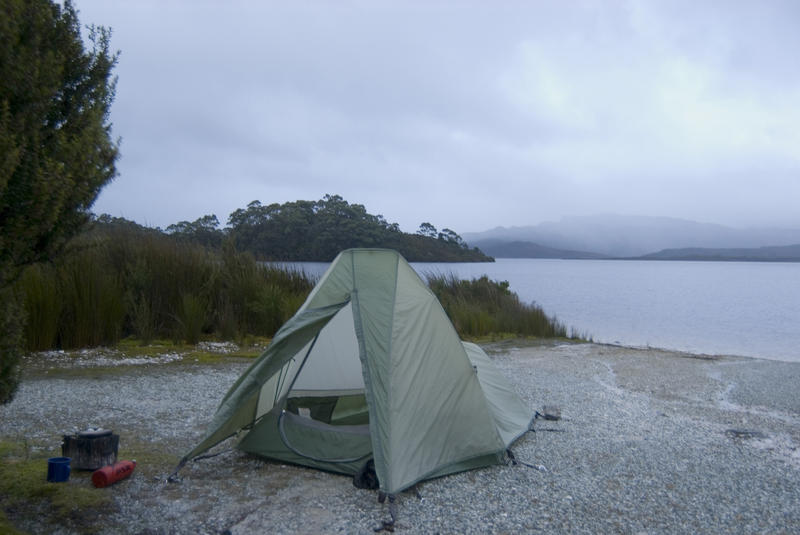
98, 195, 494, 262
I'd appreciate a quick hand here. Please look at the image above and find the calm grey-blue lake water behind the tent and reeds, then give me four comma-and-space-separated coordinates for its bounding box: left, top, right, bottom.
276, 258, 800, 362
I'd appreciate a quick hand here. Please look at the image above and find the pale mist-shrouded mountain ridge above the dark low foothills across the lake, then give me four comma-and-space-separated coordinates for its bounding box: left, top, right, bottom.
462, 215, 800, 257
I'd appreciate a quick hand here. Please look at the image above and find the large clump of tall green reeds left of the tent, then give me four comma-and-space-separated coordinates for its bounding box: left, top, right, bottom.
16, 229, 313, 351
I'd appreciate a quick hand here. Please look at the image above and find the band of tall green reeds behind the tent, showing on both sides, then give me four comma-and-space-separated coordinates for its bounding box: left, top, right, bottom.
10, 220, 568, 354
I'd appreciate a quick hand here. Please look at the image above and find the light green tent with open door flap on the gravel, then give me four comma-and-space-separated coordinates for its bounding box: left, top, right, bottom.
181, 249, 533, 495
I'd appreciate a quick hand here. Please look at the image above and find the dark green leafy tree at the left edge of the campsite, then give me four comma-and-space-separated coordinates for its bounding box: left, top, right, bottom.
0, 0, 119, 403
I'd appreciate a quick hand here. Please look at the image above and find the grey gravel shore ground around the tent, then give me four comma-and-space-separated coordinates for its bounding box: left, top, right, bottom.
0, 344, 800, 534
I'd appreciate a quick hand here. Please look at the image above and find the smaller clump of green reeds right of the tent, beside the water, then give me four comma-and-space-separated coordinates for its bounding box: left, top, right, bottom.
427, 274, 573, 338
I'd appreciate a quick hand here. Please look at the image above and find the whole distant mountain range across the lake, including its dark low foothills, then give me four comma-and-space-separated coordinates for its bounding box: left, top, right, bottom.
462, 215, 800, 261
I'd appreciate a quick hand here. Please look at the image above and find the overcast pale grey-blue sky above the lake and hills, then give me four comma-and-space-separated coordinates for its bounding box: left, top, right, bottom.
74, 0, 800, 233
